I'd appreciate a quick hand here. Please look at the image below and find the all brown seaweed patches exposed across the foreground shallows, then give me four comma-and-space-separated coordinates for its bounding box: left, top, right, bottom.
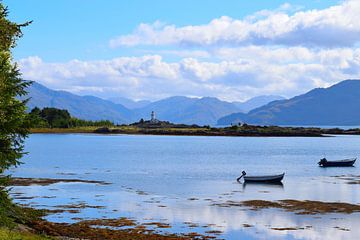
7, 175, 360, 240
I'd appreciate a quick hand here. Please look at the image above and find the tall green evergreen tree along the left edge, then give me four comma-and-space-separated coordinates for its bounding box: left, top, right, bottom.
0, 4, 31, 178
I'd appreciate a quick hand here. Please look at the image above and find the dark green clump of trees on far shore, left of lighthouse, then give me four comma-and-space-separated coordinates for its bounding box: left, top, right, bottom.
29, 107, 114, 128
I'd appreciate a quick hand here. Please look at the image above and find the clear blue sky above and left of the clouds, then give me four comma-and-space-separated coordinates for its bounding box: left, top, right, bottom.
4, 0, 338, 61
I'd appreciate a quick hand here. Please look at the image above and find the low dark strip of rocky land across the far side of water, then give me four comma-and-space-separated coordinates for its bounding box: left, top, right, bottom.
31, 124, 360, 137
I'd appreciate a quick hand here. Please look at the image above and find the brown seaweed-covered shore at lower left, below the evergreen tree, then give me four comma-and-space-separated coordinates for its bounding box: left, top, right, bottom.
6, 177, 220, 240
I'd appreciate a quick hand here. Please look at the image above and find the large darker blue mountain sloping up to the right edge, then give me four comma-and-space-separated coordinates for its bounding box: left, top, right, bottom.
218, 80, 360, 126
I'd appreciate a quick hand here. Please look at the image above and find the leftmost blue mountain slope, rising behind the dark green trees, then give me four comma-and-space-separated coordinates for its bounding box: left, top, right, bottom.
28, 82, 134, 123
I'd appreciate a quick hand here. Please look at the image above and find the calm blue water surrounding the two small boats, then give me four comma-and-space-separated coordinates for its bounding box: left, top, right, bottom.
8, 134, 360, 239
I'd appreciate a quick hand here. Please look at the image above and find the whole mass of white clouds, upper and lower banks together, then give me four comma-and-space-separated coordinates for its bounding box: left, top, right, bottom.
12, 0, 360, 104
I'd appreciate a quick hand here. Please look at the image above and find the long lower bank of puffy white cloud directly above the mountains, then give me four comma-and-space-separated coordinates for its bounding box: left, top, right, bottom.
19, 45, 360, 100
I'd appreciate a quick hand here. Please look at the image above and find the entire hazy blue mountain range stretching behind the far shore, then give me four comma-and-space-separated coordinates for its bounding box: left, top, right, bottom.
28, 80, 360, 126
